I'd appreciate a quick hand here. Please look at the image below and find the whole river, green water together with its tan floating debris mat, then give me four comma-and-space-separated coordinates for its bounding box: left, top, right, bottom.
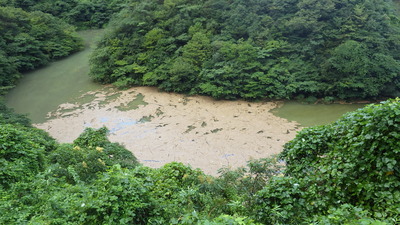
6, 30, 368, 175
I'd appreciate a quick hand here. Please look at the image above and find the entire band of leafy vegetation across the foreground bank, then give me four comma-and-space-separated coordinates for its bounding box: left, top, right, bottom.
0, 99, 400, 224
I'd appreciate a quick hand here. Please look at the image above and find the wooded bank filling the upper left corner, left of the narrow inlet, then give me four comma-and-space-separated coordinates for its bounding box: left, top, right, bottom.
0, 0, 130, 95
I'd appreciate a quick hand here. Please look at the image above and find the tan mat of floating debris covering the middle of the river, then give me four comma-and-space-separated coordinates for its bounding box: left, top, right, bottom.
36, 87, 297, 175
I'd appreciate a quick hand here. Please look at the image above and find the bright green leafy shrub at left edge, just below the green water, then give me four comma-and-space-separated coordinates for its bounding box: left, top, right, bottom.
0, 102, 56, 188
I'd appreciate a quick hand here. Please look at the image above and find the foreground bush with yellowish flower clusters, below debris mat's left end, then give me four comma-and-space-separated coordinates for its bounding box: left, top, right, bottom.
49, 127, 139, 183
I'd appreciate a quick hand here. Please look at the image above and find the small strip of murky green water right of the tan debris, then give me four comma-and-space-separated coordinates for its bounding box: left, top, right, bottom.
271, 101, 365, 127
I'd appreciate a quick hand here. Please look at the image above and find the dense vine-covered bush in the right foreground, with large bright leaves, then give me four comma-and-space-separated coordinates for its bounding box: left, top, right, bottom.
281, 99, 400, 221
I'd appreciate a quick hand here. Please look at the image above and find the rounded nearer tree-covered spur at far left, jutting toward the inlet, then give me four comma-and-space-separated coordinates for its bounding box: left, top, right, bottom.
0, 7, 83, 94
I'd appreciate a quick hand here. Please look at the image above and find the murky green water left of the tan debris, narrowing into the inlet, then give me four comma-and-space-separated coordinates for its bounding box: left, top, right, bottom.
5, 30, 103, 123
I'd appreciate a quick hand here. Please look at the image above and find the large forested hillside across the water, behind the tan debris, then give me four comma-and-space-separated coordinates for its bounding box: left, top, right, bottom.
91, 0, 400, 99
